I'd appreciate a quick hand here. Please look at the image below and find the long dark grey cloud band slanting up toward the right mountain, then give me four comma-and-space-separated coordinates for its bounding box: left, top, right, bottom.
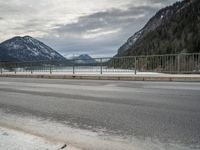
56, 6, 155, 34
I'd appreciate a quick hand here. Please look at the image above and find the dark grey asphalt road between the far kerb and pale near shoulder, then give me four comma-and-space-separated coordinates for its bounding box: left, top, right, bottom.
0, 78, 200, 145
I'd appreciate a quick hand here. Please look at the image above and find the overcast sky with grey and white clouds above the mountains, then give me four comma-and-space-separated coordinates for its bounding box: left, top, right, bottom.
0, 0, 177, 57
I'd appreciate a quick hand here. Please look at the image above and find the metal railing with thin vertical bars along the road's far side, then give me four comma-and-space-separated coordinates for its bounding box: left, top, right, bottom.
0, 53, 200, 74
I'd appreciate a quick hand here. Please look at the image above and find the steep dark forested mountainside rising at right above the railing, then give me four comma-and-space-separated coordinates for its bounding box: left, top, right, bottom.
117, 0, 200, 56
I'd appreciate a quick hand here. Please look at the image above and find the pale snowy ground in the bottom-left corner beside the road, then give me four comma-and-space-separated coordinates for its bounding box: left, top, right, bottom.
0, 126, 79, 150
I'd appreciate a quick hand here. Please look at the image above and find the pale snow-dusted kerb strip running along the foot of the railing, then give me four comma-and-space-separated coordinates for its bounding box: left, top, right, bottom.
0, 74, 200, 82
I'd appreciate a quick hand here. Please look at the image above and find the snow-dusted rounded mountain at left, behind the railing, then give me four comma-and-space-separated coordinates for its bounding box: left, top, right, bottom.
0, 36, 66, 62
